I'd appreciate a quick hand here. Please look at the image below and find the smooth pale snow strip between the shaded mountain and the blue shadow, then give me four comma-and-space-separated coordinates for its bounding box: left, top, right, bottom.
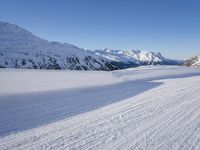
0, 69, 120, 95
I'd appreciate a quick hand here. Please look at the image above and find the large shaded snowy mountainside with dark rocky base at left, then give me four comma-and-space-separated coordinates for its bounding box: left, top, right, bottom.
0, 22, 119, 70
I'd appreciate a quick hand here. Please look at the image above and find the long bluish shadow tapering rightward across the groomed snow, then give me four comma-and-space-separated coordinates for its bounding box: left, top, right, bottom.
0, 74, 199, 137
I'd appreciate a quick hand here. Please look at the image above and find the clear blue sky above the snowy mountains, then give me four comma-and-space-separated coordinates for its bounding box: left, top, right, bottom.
0, 0, 200, 59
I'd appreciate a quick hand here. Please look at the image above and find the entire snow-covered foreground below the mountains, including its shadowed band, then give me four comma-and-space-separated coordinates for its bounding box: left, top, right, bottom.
0, 66, 200, 150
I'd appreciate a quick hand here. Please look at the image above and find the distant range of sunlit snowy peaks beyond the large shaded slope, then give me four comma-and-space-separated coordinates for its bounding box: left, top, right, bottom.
87, 49, 182, 66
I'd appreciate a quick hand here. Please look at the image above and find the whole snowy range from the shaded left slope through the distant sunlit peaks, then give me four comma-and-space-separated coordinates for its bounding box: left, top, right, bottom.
0, 22, 180, 70
